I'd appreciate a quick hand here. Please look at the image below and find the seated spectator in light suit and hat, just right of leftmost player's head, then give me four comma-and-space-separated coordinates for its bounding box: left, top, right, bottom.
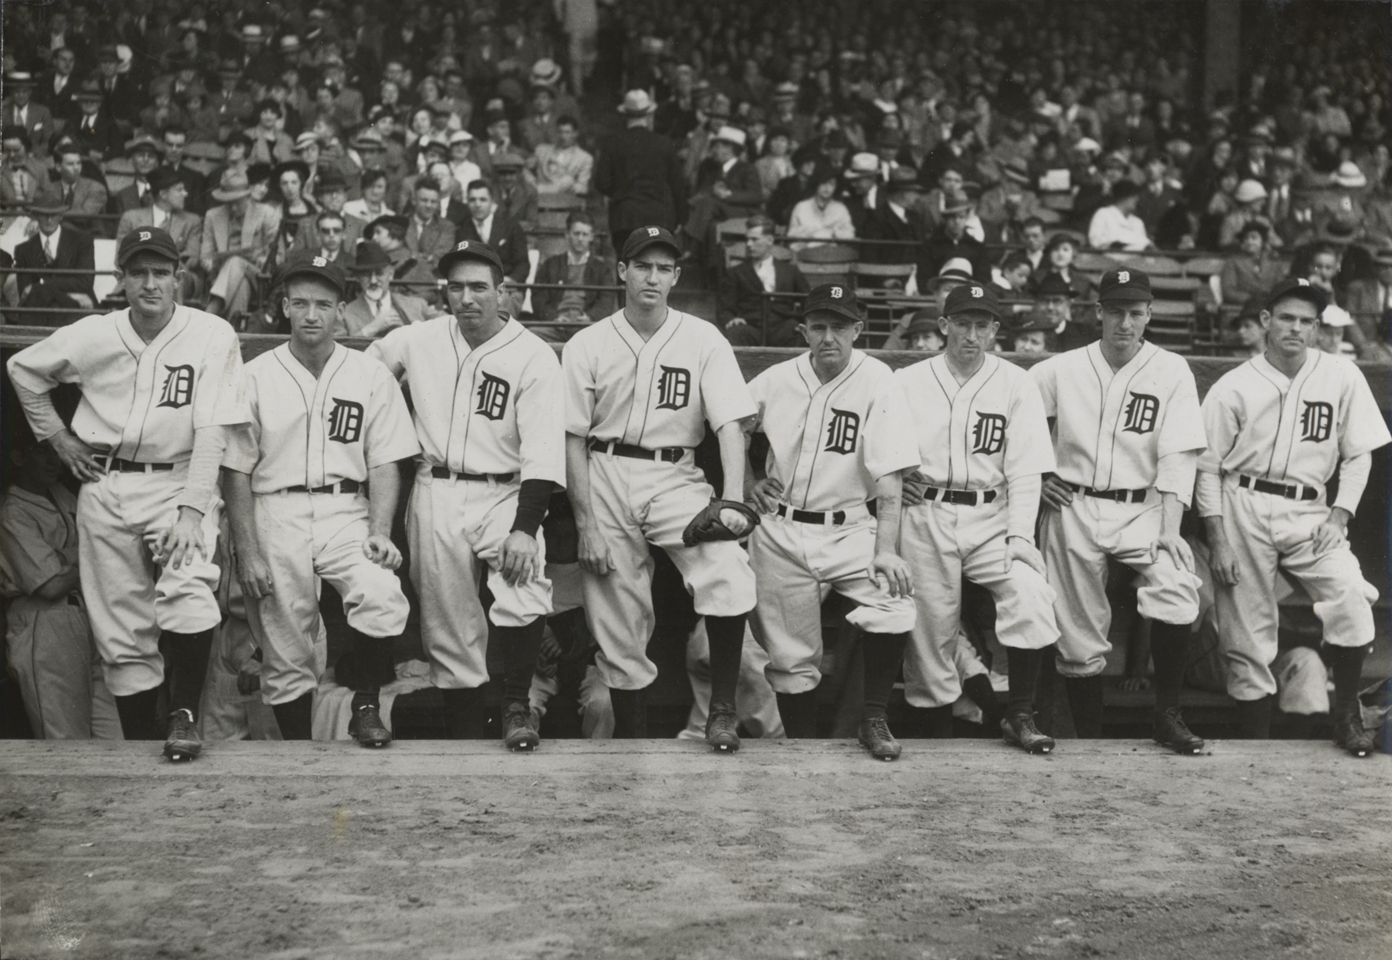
199, 170, 280, 320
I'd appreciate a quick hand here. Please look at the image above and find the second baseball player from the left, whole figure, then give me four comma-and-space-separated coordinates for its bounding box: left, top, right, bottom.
223, 256, 420, 747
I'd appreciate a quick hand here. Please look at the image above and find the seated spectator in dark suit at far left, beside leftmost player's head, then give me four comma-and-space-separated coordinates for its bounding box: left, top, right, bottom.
14, 191, 96, 327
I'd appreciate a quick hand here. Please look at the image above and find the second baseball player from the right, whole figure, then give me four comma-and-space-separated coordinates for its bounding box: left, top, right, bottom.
1030, 269, 1204, 754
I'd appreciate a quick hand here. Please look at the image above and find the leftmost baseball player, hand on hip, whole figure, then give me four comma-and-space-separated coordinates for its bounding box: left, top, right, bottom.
8, 227, 249, 761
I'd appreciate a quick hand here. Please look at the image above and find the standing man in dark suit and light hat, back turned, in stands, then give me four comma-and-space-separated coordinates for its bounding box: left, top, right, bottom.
594, 90, 686, 250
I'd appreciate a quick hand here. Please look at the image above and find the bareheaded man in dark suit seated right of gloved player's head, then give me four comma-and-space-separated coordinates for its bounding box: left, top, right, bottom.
717, 214, 809, 346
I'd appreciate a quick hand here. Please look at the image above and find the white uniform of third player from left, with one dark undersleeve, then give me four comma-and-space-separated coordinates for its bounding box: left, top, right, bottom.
367, 314, 565, 689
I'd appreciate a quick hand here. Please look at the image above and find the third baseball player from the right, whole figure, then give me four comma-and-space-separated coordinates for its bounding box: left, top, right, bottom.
895, 284, 1058, 753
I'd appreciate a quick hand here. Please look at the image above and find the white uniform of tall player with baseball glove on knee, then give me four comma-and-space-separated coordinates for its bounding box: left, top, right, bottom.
561, 310, 754, 690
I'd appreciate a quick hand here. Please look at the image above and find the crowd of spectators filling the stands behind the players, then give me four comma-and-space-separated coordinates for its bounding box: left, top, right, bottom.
0, 0, 1392, 358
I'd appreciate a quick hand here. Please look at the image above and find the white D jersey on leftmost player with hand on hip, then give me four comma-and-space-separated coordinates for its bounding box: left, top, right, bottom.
10, 306, 249, 463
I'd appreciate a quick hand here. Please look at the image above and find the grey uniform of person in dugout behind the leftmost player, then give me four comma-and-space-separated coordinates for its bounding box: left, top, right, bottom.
0, 484, 122, 740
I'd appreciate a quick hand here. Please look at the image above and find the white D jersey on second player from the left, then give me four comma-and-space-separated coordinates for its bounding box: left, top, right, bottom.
223, 344, 420, 494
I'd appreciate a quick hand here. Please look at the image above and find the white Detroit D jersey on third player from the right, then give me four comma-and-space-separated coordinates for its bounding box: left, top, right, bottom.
895, 355, 1054, 490
